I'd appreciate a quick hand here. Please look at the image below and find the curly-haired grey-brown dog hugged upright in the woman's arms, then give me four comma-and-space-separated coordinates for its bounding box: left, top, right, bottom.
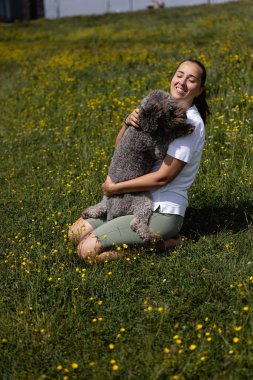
82, 90, 194, 241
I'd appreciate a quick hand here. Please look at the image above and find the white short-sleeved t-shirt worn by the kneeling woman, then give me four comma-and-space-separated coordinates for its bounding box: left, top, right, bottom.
150, 105, 205, 216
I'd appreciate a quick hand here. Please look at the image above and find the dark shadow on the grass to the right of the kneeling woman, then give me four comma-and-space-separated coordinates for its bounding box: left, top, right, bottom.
180, 201, 253, 240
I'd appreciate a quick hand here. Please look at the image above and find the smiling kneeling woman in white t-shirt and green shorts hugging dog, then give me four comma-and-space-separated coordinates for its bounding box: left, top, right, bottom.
69, 59, 209, 261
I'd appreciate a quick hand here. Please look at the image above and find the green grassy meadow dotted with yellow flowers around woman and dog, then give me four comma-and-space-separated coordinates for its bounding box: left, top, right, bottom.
0, 0, 253, 380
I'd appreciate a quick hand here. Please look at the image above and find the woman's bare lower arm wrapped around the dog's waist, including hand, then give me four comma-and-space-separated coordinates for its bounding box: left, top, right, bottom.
102, 155, 186, 197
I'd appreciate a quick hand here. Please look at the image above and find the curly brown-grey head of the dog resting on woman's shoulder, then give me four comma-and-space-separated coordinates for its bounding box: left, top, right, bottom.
138, 90, 193, 138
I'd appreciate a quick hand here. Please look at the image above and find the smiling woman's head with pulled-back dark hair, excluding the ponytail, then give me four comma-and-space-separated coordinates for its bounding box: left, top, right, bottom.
170, 61, 203, 107
